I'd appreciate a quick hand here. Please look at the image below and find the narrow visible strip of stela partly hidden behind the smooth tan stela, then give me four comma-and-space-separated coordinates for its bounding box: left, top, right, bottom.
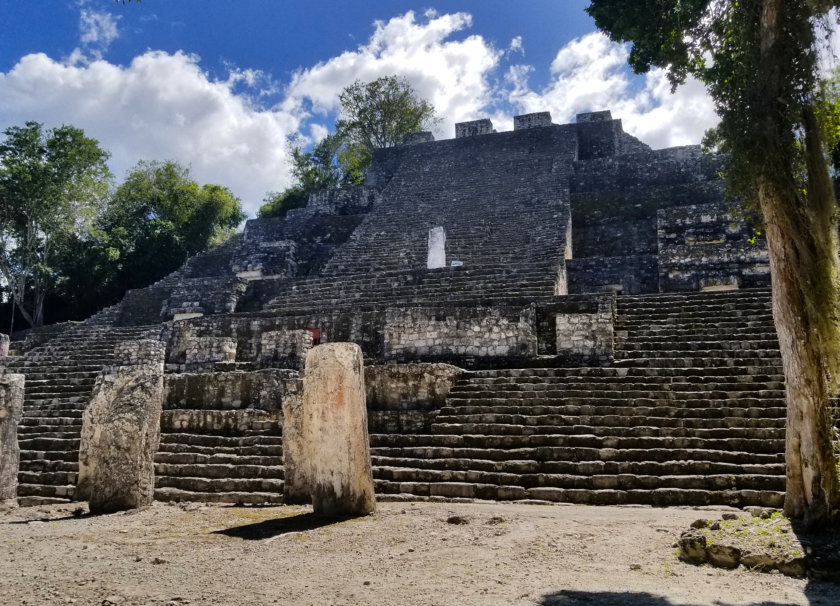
283, 380, 312, 504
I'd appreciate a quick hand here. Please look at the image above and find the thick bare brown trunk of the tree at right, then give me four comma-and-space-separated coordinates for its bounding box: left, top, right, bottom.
754, 0, 840, 528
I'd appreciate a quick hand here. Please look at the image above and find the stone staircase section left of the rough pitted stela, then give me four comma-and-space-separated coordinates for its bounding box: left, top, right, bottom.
8, 324, 150, 506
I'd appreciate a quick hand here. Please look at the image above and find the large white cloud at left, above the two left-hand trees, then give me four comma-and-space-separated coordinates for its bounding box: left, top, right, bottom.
0, 52, 300, 213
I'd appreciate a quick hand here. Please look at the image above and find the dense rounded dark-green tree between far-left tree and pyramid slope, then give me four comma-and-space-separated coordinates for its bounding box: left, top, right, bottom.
96, 161, 245, 293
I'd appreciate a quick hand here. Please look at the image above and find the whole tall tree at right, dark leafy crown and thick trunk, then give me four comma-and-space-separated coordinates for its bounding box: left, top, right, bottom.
587, 0, 840, 527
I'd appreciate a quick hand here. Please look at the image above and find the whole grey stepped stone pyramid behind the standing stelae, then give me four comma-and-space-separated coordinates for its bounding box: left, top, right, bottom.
0, 111, 796, 506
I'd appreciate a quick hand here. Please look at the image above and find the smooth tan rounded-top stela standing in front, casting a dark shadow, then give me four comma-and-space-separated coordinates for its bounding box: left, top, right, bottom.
303, 343, 376, 516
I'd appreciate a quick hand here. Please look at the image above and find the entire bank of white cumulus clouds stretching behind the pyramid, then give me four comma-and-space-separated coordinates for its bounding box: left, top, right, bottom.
0, 11, 714, 214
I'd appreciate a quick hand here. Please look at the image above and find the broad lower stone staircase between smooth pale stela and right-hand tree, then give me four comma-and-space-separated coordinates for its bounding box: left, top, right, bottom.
371, 290, 785, 506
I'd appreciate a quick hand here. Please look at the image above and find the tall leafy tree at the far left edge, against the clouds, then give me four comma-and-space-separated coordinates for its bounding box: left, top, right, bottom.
0, 122, 111, 326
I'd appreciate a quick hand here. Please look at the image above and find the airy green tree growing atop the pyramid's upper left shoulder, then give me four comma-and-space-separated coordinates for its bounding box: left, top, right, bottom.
336, 76, 436, 154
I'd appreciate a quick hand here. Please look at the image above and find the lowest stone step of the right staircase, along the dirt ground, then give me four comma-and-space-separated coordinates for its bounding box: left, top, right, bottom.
375, 480, 784, 507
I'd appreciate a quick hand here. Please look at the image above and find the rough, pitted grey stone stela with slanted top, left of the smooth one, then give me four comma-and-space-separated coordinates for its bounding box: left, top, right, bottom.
76, 360, 163, 513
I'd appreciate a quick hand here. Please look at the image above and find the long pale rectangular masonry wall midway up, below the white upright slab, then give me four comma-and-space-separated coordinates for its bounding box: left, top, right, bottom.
384, 307, 537, 360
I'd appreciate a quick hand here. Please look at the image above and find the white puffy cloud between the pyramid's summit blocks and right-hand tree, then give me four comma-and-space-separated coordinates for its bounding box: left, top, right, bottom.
506, 33, 717, 148
